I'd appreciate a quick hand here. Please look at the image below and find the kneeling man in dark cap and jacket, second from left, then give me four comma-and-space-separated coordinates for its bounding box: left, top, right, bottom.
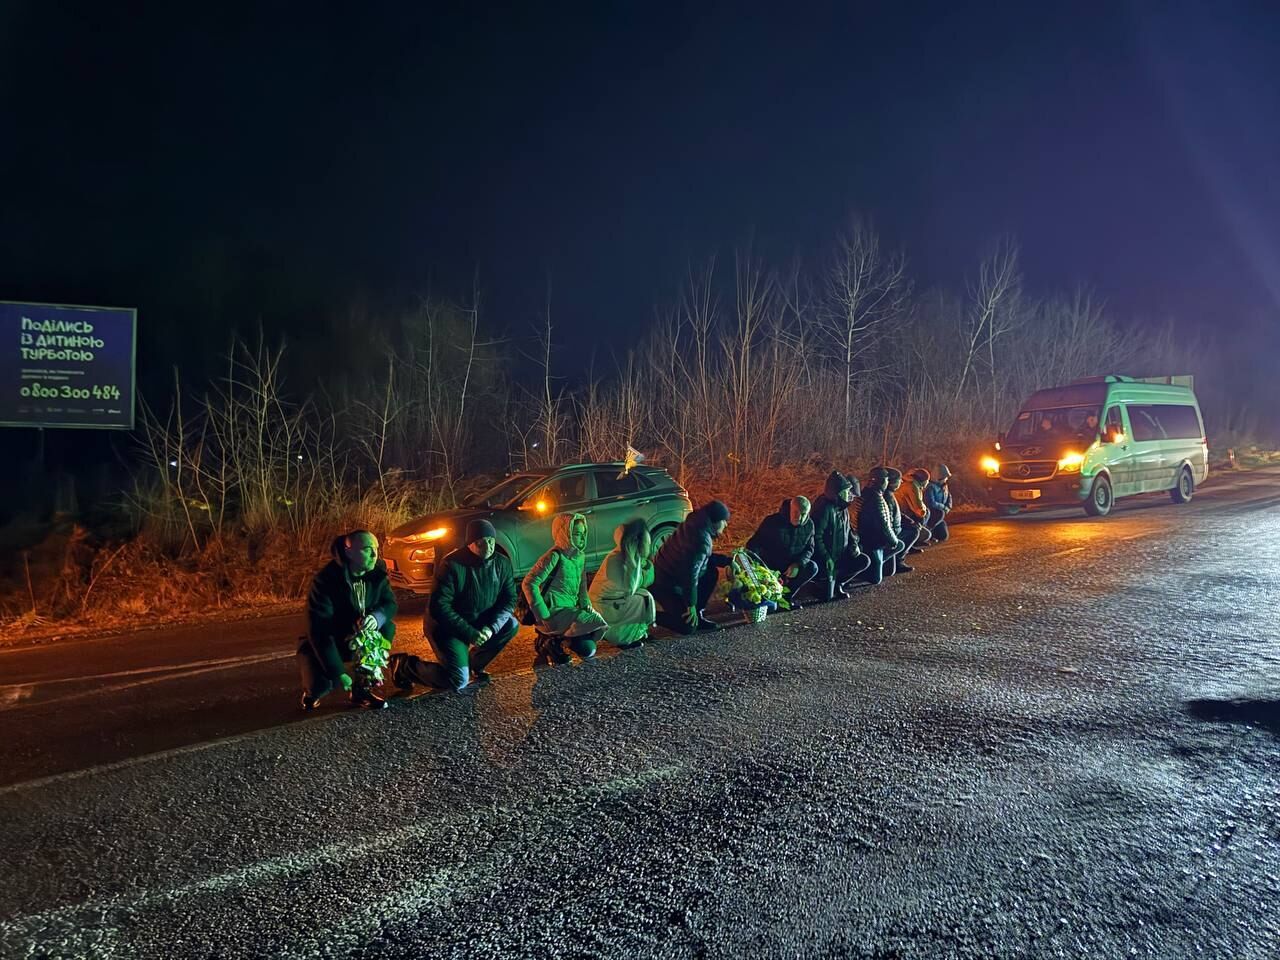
420, 520, 520, 692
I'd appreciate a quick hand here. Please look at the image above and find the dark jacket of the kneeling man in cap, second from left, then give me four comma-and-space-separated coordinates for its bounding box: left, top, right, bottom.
424, 547, 516, 644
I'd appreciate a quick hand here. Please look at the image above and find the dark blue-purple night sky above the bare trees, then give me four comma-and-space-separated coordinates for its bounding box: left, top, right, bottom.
0, 0, 1280, 379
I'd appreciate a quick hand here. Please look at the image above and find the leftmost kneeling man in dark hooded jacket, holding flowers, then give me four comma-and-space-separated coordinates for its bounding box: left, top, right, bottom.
297, 530, 396, 710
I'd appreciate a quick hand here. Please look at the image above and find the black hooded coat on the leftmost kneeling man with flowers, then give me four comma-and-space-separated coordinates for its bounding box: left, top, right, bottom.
298, 536, 396, 682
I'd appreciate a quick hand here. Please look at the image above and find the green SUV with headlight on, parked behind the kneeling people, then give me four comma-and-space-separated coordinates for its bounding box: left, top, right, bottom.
383, 463, 692, 594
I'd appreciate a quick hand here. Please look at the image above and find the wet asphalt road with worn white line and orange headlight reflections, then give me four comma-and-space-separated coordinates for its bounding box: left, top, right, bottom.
0, 471, 1280, 959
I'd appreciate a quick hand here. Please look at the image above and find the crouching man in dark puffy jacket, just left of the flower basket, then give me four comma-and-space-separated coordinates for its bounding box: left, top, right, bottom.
649, 500, 730, 634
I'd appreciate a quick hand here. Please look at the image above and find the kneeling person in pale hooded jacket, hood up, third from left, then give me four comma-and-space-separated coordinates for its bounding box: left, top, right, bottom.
524, 513, 609, 663
